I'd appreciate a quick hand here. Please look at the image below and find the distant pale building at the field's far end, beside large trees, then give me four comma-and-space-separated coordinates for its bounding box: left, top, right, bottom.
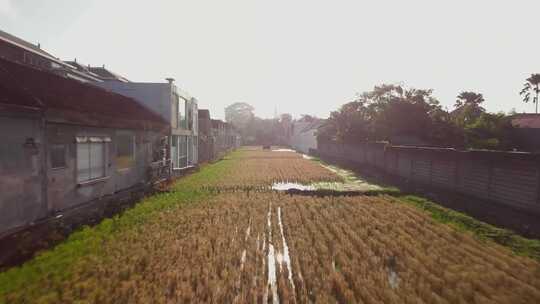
289, 117, 324, 154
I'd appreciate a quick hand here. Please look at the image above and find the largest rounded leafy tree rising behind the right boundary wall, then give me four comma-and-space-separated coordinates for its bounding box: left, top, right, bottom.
319, 84, 450, 143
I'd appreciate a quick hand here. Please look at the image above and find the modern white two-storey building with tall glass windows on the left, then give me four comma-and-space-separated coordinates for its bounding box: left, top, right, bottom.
95, 79, 199, 175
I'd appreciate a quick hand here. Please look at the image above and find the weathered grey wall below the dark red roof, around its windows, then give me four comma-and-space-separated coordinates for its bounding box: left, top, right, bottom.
0, 116, 163, 234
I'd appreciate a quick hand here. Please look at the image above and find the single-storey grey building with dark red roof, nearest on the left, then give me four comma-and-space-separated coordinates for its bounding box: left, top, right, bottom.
0, 59, 170, 234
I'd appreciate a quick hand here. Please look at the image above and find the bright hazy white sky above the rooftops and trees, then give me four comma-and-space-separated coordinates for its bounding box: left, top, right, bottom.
0, 0, 540, 118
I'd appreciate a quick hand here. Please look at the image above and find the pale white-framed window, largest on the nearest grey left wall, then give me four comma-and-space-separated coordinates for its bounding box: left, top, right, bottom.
76, 136, 111, 182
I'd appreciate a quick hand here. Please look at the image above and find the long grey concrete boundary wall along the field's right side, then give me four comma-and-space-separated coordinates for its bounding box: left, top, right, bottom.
317, 142, 540, 214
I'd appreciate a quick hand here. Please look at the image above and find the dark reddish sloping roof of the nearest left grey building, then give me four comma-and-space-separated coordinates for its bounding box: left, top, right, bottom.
0, 58, 169, 129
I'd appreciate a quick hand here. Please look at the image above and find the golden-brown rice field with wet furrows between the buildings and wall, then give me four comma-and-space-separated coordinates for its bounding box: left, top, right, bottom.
0, 150, 540, 304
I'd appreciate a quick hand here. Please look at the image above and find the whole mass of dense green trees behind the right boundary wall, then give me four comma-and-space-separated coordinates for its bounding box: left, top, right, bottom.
319, 84, 513, 150
